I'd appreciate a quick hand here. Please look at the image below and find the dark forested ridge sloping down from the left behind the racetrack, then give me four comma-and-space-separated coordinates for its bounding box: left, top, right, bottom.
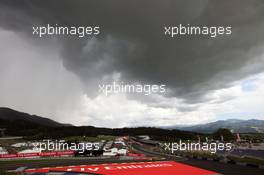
0, 108, 200, 141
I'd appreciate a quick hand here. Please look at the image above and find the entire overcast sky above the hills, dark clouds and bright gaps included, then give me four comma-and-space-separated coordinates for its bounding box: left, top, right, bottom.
0, 0, 264, 127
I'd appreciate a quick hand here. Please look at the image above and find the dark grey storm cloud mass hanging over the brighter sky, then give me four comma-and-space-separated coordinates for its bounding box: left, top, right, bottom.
0, 0, 264, 103
